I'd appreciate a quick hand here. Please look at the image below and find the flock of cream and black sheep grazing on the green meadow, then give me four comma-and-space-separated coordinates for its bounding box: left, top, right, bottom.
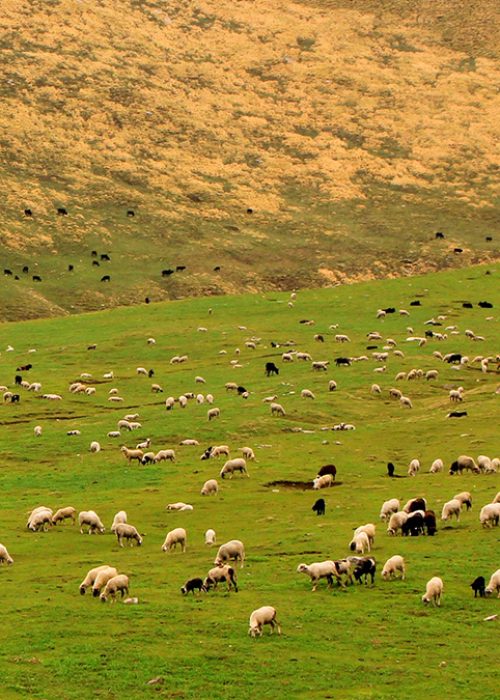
0, 284, 500, 637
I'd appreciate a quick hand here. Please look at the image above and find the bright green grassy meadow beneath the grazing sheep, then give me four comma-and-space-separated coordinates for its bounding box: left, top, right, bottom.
0, 266, 500, 700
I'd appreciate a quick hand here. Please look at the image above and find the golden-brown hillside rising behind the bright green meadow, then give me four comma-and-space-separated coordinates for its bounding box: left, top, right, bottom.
0, 0, 499, 318
